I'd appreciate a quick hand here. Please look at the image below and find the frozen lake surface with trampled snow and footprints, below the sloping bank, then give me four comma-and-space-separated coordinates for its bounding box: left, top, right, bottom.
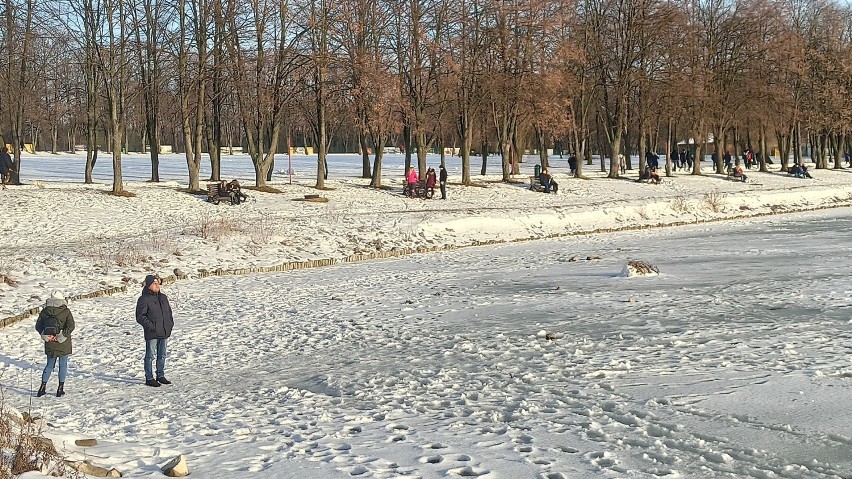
0, 209, 852, 479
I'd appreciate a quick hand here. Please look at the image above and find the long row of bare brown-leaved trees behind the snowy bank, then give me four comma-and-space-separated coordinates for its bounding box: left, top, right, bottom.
0, 0, 852, 193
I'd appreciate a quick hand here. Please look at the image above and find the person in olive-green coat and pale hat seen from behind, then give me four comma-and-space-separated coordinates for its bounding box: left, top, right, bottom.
36, 291, 74, 397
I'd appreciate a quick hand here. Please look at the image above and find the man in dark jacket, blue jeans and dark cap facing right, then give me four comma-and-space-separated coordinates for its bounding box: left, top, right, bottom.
136, 274, 175, 388
